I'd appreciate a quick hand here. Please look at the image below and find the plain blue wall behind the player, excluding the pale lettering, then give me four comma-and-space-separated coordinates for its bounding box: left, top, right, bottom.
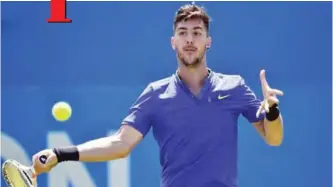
1, 2, 332, 187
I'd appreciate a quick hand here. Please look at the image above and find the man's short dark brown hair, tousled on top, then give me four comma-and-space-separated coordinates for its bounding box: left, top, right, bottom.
173, 4, 210, 32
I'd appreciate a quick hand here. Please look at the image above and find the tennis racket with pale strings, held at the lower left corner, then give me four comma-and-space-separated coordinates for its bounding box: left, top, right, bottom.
2, 155, 47, 187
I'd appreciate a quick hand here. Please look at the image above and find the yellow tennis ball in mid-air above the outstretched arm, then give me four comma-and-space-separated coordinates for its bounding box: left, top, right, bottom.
52, 101, 72, 122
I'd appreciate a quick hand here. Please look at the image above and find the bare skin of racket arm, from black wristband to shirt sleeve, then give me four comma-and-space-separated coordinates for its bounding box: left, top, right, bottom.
77, 124, 143, 162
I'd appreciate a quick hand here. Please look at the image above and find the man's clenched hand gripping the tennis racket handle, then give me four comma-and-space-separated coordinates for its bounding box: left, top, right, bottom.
32, 149, 58, 177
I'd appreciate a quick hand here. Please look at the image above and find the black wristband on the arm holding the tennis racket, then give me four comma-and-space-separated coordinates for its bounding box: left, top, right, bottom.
53, 146, 79, 163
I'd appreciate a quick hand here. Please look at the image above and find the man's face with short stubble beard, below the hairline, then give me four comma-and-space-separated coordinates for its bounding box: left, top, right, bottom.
171, 19, 211, 67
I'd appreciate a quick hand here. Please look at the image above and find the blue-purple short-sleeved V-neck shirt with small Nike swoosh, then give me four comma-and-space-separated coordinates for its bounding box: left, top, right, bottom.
124, 71, 264, 187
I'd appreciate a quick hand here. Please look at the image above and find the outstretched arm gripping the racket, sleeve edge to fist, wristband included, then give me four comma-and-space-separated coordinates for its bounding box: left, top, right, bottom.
32, 123, 143, 176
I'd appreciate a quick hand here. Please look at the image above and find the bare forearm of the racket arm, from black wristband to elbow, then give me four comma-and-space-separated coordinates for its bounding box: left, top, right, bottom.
77, 135, 130, 162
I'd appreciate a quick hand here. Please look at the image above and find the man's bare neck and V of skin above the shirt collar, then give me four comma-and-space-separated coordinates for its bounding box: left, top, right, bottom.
178, 63, 208, 95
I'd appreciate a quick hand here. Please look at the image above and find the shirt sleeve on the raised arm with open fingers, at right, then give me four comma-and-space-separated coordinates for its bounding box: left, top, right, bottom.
240, 79, 265, 123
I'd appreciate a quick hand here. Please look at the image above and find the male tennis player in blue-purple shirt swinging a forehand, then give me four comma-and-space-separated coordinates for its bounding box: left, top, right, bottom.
33, 4, 283, 187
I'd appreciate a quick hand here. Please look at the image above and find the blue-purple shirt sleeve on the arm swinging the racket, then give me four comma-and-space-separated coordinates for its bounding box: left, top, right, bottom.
123, 85, 154, 136
